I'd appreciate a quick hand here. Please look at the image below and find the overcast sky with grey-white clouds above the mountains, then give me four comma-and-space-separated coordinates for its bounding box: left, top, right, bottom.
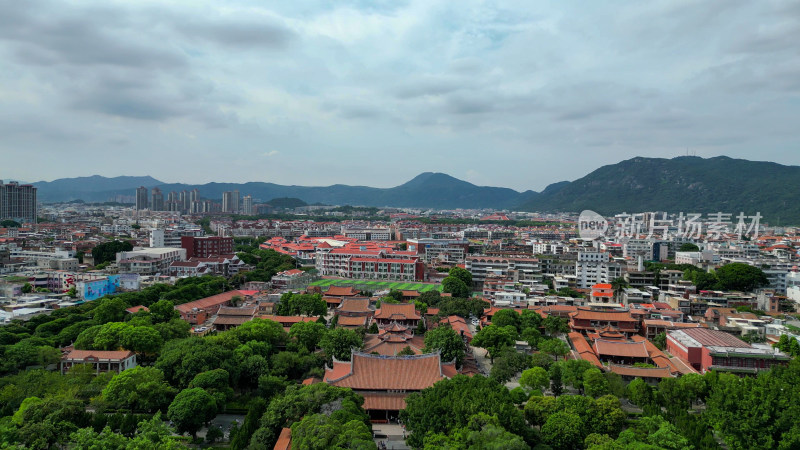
0, 0, 800, 190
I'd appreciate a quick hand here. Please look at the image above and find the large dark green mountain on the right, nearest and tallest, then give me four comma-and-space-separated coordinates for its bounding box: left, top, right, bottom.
515, 156, 800, 224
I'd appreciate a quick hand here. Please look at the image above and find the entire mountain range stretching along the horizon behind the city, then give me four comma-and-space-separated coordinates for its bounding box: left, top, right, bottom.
28, 156, 800, 224
